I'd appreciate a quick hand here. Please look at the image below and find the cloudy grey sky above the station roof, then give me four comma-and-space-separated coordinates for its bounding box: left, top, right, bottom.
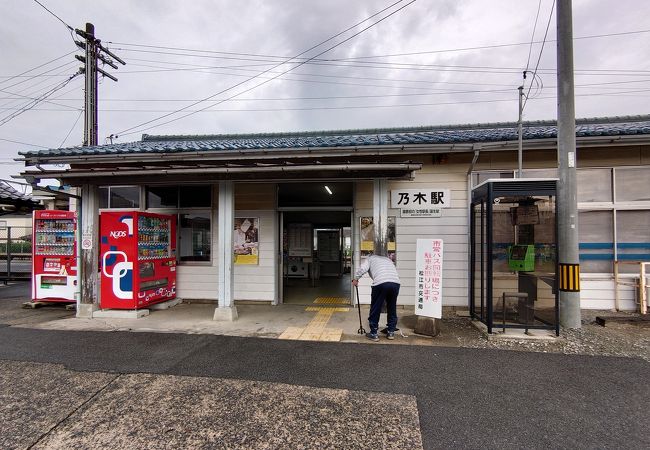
0, 0, 650, 183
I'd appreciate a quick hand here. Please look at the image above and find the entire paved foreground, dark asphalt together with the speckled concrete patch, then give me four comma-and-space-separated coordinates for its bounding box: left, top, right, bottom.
0, 327, 650, 449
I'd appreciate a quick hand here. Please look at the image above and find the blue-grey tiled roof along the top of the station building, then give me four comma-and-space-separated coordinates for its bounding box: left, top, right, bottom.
20, 116, 650, 158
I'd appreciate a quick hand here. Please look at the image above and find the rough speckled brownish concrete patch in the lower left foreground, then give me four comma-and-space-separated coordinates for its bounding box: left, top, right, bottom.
0, 361, 422, 449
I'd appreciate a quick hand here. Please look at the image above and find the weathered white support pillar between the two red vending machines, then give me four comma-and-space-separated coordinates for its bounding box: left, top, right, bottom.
77, 184, 99, 319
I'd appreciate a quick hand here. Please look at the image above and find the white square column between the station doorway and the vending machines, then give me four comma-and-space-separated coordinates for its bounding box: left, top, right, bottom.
214, 181, 237, 321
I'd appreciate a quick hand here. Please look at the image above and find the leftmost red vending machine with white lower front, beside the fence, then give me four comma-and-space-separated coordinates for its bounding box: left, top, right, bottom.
32, 210, 77, 302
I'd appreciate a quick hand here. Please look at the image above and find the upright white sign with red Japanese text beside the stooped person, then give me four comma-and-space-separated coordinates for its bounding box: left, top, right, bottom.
415, 239, 442, 319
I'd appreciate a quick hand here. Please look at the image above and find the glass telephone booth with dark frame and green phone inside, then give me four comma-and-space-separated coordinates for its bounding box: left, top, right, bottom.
469, 178, 560, 335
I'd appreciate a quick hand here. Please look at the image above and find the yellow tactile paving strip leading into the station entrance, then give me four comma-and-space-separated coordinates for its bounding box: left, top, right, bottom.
278, 297, 350, 342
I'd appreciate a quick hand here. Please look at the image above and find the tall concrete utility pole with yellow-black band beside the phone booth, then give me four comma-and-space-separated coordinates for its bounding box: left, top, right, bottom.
556, 0, 581, 328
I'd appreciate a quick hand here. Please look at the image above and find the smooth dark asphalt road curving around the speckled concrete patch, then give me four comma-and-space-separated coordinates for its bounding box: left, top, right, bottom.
0, 326, 650, 449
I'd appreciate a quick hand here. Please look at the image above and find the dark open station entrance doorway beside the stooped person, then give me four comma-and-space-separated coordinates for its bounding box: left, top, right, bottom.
278, 182, 353, 306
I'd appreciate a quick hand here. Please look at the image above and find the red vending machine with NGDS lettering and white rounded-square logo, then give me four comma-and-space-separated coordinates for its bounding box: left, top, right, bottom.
99, 211, 176, 309
